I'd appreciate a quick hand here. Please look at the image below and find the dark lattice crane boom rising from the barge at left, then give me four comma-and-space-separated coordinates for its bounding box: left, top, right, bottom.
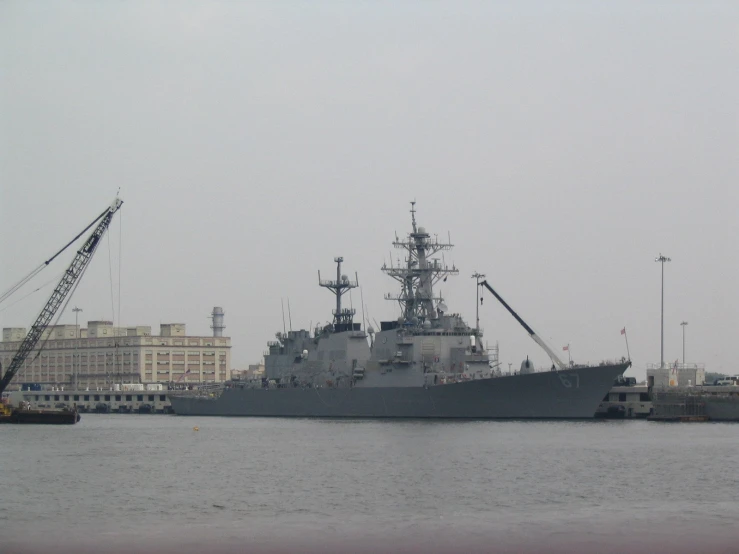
0, 197, 123, 394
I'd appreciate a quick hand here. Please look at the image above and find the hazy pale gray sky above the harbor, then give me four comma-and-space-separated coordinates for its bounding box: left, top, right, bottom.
0, 1, 739, 377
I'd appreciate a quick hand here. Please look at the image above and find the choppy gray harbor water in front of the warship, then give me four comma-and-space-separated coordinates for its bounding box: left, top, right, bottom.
0, 414, 739, 553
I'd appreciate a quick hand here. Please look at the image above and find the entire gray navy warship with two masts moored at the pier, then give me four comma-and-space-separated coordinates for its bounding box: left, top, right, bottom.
169, 202, 630, 419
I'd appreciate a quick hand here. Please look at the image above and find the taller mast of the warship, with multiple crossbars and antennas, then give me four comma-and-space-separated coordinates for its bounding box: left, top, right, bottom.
382, 201, 459, 323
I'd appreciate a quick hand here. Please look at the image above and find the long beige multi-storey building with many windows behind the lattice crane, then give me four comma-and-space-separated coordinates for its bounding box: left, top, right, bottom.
0, 321, 231, 389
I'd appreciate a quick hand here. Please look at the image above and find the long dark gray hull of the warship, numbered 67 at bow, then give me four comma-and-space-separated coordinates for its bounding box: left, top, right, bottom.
170, 362, 630, 419
